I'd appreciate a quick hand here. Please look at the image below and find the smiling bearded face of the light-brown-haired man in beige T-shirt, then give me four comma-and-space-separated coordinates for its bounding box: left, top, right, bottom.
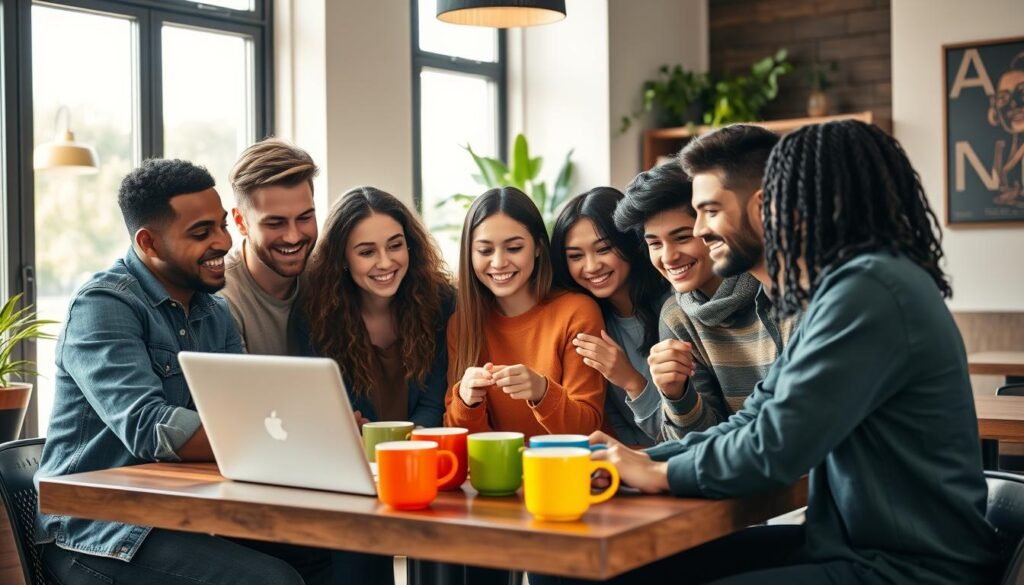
232, 181, 316, 278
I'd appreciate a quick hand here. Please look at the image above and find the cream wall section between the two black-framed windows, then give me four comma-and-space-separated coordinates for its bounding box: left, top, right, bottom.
274, 0, 413, 211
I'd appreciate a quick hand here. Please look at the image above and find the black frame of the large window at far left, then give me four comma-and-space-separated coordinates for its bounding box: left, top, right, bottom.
0, 0, 274, 436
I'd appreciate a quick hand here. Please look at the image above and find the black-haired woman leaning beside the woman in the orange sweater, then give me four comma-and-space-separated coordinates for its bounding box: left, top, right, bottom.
551, 186, 669, 447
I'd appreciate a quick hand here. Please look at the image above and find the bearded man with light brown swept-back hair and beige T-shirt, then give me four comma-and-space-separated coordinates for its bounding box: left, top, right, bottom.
220, 138, 318, 356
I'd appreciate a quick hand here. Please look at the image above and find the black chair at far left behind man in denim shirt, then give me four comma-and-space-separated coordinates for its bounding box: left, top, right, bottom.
0, 438, 47, 585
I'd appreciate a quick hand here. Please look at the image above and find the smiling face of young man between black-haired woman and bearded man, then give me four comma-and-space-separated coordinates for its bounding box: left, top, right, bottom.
643, 207, 721, 297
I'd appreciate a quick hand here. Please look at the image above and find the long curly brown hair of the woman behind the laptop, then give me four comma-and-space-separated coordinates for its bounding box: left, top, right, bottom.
302, 186, 454, 395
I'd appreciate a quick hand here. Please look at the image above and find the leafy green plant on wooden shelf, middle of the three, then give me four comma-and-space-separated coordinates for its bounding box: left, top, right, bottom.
705, 49, 793, 126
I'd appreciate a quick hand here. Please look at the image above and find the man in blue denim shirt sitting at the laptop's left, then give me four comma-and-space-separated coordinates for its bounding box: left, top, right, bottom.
36, 160, 330, 585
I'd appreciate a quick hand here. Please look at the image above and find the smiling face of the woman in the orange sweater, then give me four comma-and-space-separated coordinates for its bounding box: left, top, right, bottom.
472, 213, 537, 315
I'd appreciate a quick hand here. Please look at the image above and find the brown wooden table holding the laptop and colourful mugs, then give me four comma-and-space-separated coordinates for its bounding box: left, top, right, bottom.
39, 463, 807, 579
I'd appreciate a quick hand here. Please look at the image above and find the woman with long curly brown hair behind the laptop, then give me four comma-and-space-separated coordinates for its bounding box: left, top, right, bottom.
302, 186, 454, 426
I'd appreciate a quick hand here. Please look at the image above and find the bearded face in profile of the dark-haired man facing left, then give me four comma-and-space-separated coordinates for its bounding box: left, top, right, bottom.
693, 172, 764, 278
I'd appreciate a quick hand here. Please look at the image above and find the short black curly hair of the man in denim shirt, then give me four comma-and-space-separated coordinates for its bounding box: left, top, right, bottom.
118, 159, 216, 236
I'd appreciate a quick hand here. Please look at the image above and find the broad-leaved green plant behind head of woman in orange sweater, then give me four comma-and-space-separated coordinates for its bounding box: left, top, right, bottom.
431, 134, 572, 232
